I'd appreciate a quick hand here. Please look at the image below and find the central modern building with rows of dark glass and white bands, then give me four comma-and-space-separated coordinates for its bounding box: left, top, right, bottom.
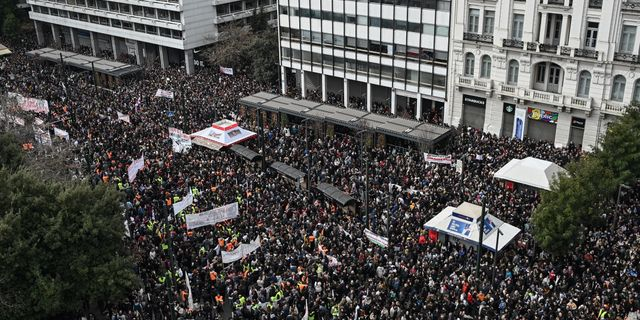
278, 0, 451, 119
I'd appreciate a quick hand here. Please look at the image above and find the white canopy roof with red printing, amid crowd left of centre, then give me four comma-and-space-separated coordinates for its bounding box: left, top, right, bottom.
191, 120, 256, 150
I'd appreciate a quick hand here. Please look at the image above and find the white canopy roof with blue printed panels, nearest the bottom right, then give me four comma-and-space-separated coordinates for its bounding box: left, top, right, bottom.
424, 202, 520, 252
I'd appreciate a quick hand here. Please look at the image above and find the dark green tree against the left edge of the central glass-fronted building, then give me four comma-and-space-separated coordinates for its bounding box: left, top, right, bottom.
251, 30, 278, 83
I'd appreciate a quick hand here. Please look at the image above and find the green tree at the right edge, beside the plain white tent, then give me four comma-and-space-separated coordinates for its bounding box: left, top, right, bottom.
532, 106, 640, 255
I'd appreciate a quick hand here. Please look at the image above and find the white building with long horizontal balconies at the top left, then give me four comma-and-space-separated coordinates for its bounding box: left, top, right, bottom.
27, 0, 276, 73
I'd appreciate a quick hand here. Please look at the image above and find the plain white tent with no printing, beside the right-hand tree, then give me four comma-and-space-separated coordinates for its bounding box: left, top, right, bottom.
493, 157, 567, 191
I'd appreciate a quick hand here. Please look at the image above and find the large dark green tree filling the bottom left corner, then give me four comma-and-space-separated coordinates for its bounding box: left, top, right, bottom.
0, 170, 138, 319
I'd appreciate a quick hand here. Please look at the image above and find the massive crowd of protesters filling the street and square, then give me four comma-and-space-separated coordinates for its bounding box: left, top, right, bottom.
0, 35, 640, 319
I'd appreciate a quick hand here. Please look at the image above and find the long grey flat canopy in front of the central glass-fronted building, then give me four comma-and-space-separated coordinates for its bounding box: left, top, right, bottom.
239, 92, 452, 145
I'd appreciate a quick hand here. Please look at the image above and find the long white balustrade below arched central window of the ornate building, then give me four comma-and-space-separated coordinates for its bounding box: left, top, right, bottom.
496, 83, 592, 112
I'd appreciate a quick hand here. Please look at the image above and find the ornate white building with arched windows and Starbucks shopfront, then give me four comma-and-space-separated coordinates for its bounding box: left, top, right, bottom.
445, 0, 640, 150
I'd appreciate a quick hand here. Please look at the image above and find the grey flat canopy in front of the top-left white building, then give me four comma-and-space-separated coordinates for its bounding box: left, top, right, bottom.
27, 48, 142, 77
